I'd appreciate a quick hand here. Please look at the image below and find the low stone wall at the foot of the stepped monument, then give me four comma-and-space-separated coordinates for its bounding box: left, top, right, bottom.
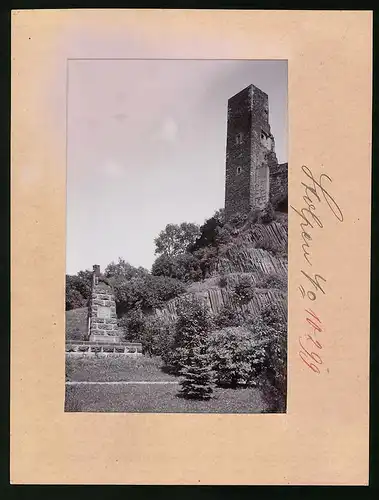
65, 340, 142, 356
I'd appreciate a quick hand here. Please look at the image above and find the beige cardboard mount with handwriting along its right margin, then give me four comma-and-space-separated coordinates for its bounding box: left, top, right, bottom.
11, 9, 372, 485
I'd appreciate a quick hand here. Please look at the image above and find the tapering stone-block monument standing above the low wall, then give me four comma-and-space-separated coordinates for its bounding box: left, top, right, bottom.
88, 265, 120, 343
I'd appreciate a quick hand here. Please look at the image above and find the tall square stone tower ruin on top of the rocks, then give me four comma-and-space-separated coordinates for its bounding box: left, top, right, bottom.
225, 85, 278, 219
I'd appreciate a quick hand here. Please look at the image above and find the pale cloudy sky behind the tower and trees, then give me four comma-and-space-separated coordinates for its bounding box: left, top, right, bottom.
67, 60, 287, 274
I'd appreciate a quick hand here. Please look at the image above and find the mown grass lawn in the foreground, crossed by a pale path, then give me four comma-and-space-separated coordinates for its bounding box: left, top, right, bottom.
65, 357, 266, 413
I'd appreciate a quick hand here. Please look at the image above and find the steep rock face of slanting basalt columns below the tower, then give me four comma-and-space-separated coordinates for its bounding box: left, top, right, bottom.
156, 213, 288, 320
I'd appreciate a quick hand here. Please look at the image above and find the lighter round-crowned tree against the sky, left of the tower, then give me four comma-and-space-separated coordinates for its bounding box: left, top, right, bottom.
154, 222, 200, 257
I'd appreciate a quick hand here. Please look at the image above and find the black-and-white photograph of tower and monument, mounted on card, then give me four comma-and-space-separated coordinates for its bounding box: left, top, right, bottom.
65, 59, 288, 414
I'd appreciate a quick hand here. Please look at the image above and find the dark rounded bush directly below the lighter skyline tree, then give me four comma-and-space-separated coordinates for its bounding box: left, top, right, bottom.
151, 253, 203, 282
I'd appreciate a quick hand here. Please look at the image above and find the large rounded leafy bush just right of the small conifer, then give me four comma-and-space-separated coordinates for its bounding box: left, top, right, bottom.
208, 327, 265, 387
